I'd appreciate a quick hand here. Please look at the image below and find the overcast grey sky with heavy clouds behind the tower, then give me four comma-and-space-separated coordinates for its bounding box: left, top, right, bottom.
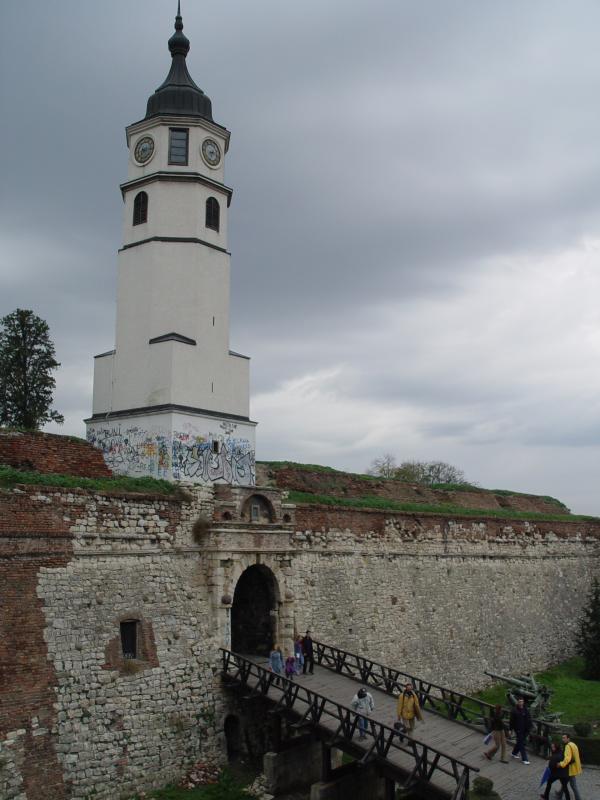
0, 0, 600, 514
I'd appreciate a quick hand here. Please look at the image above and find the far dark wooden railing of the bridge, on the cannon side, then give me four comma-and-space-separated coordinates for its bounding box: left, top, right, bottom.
313, 641, 555, 757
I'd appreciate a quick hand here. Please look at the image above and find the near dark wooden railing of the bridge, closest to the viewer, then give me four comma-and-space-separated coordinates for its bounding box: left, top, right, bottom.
221, 645, 479, 800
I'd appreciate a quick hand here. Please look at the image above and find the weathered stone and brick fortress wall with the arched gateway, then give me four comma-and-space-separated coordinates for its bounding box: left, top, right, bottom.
0, 438, 600, 800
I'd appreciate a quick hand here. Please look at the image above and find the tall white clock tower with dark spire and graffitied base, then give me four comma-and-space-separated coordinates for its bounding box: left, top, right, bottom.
86, 8, 256, 485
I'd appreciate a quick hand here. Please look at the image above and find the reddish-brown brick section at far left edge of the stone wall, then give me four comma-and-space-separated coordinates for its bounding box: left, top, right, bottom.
0, 492, 73, 800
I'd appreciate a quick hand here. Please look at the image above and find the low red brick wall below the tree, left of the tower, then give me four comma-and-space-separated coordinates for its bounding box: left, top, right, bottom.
0, 430, 112, 478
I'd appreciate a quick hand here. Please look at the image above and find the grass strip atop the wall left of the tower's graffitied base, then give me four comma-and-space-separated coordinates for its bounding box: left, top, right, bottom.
0, 464, 177, 494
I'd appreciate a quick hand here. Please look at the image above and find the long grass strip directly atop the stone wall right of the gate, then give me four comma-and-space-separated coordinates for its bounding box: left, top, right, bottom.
288, 491, 600, 522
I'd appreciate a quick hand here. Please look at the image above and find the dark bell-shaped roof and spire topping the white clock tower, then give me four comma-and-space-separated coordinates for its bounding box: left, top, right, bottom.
146, 0, 212, 121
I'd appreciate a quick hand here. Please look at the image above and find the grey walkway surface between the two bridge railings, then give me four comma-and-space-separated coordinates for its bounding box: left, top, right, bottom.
247, 657, 600, 800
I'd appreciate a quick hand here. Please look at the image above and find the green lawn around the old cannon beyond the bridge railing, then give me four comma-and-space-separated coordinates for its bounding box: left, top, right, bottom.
477, 658, 600, 725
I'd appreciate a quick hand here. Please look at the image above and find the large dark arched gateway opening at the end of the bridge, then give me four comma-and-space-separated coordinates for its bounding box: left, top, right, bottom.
231, 564, 277, 656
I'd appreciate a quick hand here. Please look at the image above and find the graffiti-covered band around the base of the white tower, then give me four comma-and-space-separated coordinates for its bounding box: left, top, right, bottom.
88, 423, 255, 486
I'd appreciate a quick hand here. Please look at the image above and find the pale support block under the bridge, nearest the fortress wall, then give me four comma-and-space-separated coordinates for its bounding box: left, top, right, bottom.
263, 737, 323, 794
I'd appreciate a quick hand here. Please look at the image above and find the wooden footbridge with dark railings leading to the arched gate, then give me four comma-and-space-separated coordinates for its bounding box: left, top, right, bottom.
223, 642, 551, 800
